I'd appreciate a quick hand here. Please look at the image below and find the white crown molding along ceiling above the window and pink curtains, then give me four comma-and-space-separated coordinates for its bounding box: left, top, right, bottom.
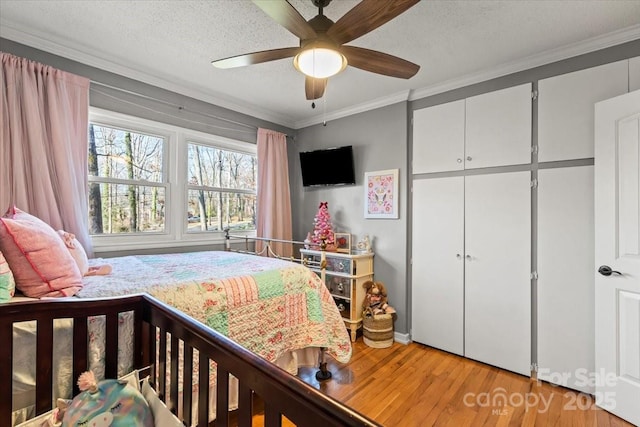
0, 18, 294, 128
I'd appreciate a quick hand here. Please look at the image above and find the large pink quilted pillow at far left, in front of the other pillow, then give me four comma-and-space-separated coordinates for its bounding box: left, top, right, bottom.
0, 207, 82, 298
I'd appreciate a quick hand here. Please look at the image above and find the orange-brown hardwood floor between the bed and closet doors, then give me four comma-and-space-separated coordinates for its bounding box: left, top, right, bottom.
299, 338, 631, 427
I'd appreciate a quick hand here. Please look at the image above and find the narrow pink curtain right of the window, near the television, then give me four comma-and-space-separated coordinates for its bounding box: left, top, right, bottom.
256, 129, 292, 257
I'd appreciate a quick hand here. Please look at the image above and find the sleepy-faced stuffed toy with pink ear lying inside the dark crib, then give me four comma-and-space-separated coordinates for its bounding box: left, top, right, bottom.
62, 371, 153, 427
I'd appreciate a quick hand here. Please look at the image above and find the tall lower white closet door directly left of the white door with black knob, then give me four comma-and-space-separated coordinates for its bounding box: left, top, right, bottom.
537, 166, 595, 393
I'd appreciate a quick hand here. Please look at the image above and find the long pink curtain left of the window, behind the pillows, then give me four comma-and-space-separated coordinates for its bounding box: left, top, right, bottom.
0, 52, 93, 254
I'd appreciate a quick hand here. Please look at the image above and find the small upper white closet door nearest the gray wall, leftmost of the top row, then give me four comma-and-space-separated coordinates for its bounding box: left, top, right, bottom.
413, 99, 464, 174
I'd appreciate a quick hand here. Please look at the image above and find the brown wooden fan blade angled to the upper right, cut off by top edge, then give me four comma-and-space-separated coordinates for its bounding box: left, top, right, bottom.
327, 0, 420, 44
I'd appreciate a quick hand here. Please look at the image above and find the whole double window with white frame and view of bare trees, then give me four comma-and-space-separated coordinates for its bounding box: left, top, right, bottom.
88, 108, 257, 251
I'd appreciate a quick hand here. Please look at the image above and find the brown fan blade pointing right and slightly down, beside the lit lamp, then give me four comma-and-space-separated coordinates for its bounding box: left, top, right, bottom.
340, 46, 420, 79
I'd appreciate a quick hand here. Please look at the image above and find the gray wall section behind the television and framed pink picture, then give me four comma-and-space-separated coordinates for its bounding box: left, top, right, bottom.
288, 102, 408, 333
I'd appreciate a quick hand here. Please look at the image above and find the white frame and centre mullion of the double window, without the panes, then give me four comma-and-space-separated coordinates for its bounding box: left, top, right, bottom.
89, 107, 257, 252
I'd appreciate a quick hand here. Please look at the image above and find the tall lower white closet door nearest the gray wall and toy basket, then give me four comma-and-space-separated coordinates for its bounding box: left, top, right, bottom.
411, 177, 464, 355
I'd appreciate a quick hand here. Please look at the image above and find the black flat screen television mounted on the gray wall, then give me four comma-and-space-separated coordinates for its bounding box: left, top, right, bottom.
300, 145, 356, 187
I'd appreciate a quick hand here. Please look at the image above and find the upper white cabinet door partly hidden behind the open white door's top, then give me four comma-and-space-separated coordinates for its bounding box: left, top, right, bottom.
538, 60, 629, 162
